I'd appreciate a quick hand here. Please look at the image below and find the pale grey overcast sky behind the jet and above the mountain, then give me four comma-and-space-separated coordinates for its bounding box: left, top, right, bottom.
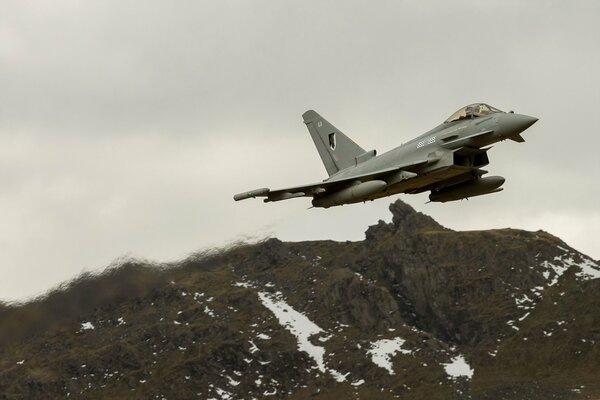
0, 0, 600, 300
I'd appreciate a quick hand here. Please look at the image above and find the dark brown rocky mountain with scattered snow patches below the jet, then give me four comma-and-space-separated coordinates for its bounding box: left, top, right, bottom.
0, 201, 600, 400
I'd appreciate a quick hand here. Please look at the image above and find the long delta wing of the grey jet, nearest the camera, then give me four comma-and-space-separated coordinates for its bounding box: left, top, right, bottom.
233, 160, 432, 202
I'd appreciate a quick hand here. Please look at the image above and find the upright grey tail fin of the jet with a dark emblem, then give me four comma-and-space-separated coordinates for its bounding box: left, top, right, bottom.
302, 110, 365, 176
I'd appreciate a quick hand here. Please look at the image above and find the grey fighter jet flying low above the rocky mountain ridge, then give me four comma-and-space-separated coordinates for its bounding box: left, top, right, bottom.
233, 103, 538, 208
